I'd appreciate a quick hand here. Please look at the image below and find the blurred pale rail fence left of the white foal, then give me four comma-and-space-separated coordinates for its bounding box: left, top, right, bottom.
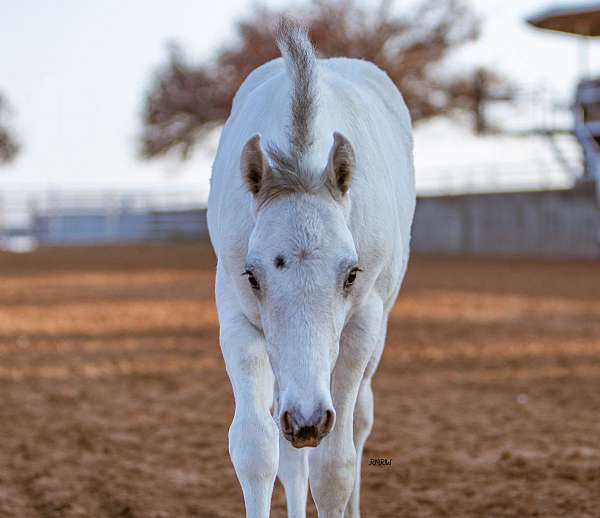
0, 190, 207, 250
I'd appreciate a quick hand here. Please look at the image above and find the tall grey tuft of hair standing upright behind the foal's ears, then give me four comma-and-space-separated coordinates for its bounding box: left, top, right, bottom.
271, 17, 317, 167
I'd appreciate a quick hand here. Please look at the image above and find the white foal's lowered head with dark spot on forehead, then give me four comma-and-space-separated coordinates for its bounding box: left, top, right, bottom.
241, 133, 361, 448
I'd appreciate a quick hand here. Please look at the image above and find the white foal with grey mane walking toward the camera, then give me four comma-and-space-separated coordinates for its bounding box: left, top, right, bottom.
208, 20, 415, 517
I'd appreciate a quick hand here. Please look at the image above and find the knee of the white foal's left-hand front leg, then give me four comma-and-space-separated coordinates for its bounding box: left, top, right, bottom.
229, 412, 279, 480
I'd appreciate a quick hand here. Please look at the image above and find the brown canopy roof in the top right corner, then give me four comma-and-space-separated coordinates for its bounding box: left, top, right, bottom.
526, 2, 600, 37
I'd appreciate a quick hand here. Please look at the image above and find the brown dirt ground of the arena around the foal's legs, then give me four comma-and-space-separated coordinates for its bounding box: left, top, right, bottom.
0, 244, 600, 518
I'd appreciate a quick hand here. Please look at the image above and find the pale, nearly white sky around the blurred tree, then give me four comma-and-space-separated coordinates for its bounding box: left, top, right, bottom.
0, 0, 600, 197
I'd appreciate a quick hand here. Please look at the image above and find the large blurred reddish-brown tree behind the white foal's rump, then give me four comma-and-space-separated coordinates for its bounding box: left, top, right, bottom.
141, 0, 478, 158
